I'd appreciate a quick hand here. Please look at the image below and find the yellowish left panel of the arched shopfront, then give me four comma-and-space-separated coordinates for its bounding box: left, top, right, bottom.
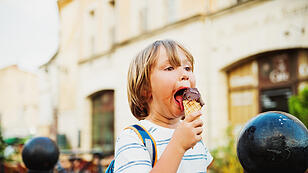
228, 61, 258, 125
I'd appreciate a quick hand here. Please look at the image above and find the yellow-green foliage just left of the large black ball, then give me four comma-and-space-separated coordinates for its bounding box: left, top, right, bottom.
210, 126, 244, 173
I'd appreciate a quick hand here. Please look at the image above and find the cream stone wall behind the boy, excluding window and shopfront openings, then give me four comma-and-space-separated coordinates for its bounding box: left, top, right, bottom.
45, 0, 308, 149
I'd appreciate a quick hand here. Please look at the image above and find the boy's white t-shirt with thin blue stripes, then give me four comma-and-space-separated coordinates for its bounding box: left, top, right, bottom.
114, 120, 213, 173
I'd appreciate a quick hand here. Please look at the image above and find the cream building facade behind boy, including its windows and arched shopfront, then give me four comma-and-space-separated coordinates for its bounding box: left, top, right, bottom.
42, 0, 308, 153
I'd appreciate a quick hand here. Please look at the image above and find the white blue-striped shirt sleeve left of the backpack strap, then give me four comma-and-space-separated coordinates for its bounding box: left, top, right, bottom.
114, 129, 152, 173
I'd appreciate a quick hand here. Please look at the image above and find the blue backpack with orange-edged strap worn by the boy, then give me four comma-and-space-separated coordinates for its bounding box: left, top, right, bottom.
105, 124, 157, 173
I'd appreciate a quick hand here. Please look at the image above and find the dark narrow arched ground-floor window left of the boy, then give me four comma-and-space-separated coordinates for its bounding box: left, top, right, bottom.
92, 90, 114, 153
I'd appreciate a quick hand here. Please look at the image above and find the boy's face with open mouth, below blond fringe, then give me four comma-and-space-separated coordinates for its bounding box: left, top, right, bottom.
149, 46, 196, 118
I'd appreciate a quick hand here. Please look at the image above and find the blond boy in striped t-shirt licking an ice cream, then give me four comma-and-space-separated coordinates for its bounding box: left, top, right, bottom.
114, 40, 213, 173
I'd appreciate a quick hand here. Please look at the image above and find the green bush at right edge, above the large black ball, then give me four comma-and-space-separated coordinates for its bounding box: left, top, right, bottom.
288, 87, 308, 128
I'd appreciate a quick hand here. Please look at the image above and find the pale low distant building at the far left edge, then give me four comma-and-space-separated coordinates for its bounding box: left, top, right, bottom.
0, 65, 40, 137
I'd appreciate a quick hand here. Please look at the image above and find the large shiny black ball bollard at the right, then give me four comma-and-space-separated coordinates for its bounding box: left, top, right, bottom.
237, 111, 308, 173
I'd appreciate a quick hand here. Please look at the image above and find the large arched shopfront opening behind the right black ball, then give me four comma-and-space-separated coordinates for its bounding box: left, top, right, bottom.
227, 49, 308, 125
